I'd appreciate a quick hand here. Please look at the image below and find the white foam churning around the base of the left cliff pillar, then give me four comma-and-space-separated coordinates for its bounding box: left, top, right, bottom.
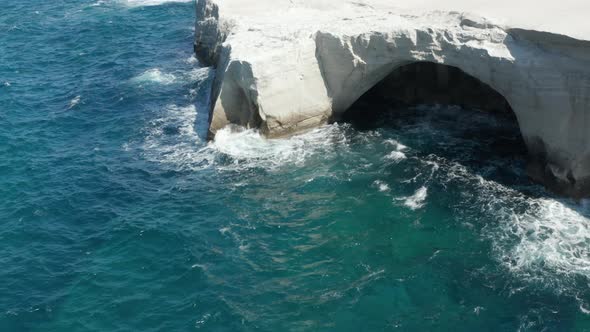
143, 105, 346, 170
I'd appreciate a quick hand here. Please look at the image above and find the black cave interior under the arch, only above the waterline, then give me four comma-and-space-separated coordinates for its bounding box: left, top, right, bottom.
342, 62, 518, 129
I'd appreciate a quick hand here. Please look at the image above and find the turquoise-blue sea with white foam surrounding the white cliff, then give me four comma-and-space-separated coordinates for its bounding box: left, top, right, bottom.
0, 0, 590, 331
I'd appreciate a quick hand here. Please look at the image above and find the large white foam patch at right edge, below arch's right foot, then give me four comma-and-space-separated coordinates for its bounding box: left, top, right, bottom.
439, 160, 590, 304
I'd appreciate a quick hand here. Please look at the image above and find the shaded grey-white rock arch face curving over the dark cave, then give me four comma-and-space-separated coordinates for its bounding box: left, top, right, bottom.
315, 29, 590, 197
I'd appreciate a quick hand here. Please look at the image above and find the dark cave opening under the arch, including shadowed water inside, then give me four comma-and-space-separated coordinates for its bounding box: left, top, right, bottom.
341, 62, 528, 189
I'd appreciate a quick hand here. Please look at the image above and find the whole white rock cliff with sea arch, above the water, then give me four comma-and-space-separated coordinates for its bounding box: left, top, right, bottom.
195, 0, 590, 196
